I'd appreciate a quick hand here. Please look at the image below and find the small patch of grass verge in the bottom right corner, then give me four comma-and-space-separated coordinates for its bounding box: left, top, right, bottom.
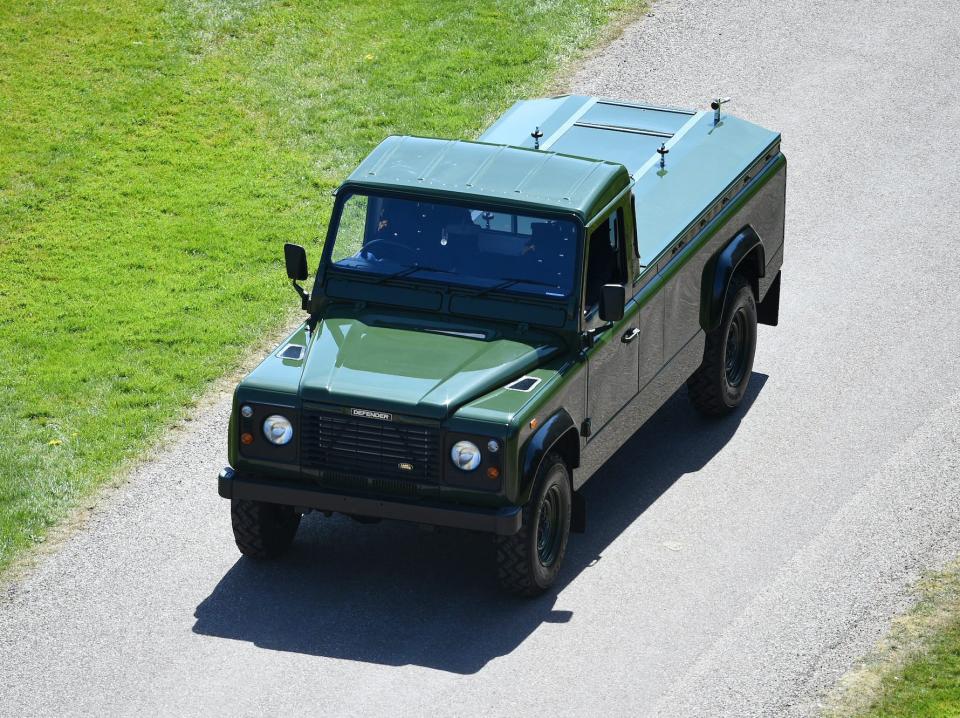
823, 561, 960, 718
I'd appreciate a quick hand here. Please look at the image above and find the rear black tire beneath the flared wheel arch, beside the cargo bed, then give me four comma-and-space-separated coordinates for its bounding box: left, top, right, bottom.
687, 274, 757, 416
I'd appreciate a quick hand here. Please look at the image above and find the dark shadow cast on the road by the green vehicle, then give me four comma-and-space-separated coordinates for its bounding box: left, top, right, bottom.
193, 373, 767, 674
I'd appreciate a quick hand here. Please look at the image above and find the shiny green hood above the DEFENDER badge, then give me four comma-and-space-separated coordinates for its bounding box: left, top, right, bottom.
300, 317, 560, 419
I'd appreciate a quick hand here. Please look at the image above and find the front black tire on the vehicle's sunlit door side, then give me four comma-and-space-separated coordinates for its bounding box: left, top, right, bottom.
496, 454, 573, 596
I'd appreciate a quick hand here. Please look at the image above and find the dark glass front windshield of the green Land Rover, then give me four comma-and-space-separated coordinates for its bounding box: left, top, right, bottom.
331, 194, 577, 298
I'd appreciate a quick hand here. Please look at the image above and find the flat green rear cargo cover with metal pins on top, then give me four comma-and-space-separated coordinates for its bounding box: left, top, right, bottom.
480, 95, 780, 264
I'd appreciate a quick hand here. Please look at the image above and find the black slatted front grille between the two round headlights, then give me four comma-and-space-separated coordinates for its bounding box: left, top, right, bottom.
300, 411, 440, 483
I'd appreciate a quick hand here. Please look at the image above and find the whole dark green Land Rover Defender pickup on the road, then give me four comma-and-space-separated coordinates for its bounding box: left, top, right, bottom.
219, 96, 786, 595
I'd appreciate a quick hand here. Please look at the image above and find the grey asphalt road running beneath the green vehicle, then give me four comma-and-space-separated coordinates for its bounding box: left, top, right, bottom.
0, 0, 960, 716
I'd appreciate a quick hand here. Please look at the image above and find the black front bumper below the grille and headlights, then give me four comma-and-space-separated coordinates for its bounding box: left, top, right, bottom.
217, 466, 521, 536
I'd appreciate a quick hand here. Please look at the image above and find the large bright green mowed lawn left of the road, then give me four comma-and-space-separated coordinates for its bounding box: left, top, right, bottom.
0, 0, 637, 568
